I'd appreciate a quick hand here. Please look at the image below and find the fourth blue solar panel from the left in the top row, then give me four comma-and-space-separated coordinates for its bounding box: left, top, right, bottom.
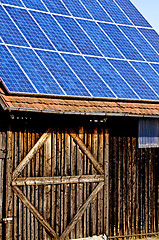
63, 0, 92, 19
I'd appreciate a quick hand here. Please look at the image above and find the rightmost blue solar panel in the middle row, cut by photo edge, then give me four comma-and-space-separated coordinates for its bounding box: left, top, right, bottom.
139, 28, 159, 53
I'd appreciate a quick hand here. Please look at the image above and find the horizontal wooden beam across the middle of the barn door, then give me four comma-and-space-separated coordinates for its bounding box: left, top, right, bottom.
12, 175, 104, 186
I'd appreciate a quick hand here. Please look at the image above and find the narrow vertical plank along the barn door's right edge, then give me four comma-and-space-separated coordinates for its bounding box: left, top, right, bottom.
103, 129, 110, 235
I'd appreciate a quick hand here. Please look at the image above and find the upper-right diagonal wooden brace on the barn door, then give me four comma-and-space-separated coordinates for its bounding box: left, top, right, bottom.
69, 129, 104, 174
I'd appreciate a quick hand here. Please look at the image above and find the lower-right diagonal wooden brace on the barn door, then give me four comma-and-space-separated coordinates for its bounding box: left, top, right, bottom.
60, 182, 104, 240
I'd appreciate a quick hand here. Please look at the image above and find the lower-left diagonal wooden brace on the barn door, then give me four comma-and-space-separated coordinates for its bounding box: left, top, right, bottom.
12, 186, 59, 239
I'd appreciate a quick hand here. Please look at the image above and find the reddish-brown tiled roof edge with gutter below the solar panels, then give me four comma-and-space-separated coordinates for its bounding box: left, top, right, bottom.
0, 89, 159, 118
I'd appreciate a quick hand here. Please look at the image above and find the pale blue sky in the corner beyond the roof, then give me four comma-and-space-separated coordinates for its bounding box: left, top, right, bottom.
131, 0, 159, 33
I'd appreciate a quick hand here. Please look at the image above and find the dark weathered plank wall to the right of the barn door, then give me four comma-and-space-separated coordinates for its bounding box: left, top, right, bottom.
110, 136, 159, 236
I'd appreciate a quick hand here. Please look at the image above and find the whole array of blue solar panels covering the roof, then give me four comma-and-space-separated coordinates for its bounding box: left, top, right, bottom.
0, 0, 159, 100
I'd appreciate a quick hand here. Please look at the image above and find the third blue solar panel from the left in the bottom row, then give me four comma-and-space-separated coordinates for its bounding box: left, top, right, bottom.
37, 51, 90, 96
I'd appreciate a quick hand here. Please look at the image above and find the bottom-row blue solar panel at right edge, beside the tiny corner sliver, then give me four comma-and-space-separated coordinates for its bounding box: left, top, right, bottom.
132, 62, 159, 95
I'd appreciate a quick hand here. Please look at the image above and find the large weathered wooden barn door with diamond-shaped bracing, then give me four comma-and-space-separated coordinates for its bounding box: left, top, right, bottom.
6, 128, 109, 240
